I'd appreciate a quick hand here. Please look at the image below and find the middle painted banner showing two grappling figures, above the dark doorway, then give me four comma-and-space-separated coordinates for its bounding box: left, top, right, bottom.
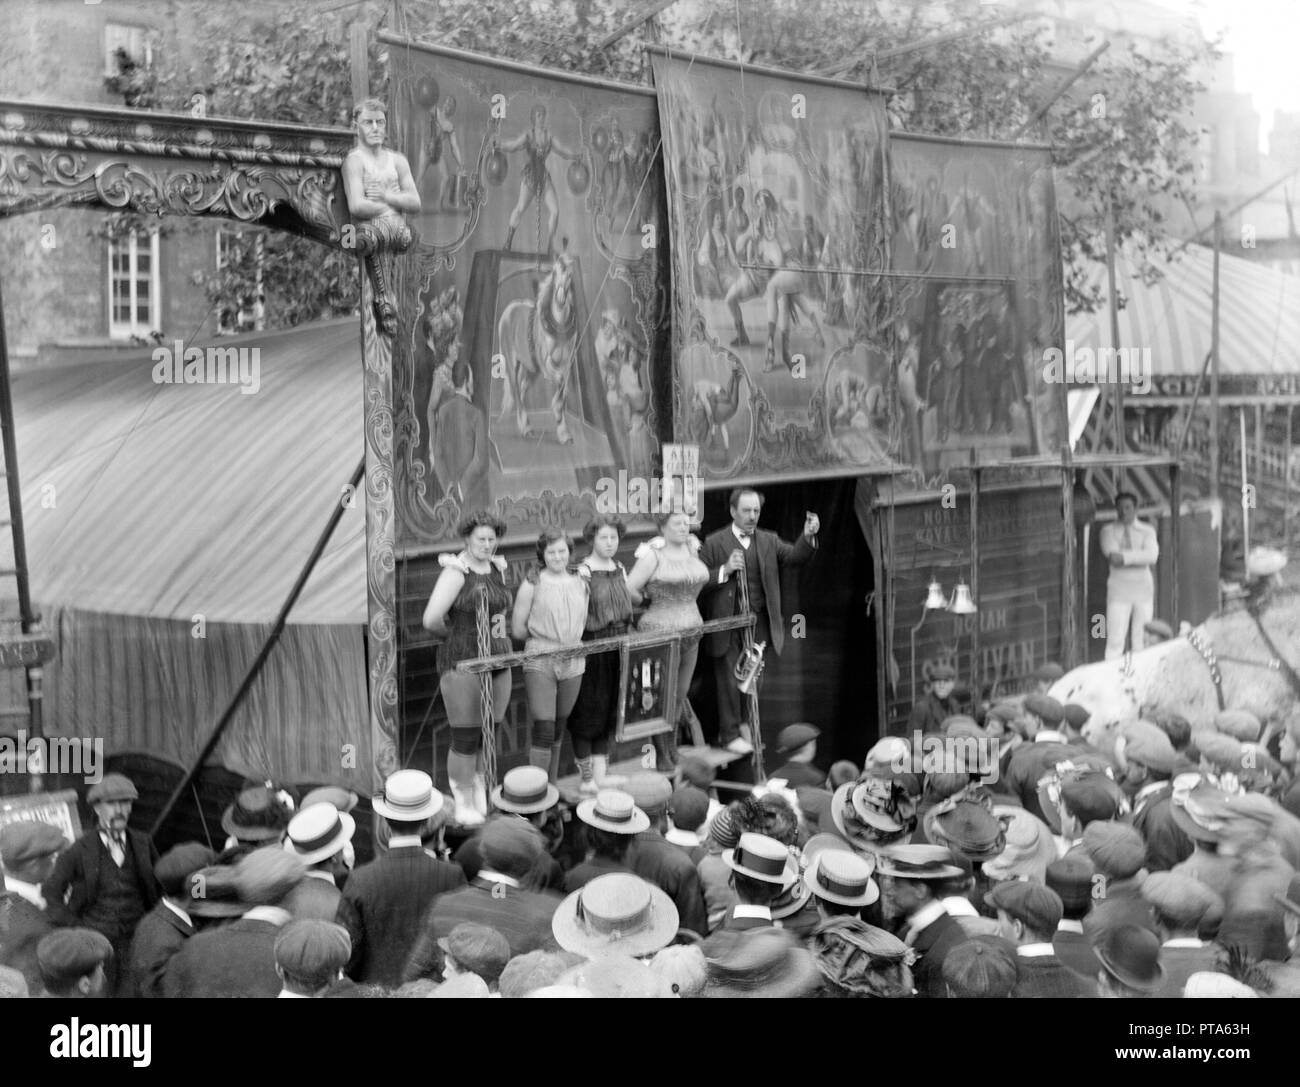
653, 52, 897, 478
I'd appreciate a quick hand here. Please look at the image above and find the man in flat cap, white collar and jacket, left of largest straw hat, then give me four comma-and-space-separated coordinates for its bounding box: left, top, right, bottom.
402, 815, 564, 982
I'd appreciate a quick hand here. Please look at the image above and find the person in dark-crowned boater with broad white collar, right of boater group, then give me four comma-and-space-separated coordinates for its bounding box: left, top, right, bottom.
878, 845, 970, 997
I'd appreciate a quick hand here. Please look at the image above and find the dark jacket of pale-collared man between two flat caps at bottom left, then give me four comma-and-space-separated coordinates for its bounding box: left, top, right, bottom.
163, 918, 282, 999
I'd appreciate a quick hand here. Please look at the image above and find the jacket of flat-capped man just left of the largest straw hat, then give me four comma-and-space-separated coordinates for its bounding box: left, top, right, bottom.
402, 878, 564, 982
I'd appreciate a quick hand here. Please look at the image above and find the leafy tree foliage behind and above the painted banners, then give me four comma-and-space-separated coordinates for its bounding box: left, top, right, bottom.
98, 0, 1216, 326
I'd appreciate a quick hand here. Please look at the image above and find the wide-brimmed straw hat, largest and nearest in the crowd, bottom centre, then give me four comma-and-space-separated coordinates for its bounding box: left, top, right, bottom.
551, 872, 677, 958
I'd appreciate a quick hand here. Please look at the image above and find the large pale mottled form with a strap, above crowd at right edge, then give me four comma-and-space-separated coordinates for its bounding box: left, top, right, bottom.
1048, 588, 1300, 729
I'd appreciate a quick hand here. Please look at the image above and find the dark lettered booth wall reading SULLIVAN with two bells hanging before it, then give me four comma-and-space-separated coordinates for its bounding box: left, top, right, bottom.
858, 482, 1062, 733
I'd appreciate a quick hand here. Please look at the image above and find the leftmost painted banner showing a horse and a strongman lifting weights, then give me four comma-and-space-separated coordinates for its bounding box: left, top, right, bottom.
390, 46, 667, 551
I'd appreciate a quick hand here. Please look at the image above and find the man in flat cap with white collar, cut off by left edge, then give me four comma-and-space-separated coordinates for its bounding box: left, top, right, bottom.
0, 819, 68, 995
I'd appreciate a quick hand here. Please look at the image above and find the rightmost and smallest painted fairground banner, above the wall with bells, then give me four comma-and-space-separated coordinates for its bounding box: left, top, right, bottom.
889, 137, 1066, 476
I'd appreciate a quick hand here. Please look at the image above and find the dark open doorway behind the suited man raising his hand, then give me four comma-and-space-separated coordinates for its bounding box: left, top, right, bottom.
690, 478, 878, 780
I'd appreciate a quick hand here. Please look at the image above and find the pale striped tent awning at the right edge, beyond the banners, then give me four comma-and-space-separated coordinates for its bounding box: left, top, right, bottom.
1066, 246, 1300, 406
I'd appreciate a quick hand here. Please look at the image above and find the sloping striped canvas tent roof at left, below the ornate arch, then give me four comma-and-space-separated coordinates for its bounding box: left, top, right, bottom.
11, 320, 365, 623
